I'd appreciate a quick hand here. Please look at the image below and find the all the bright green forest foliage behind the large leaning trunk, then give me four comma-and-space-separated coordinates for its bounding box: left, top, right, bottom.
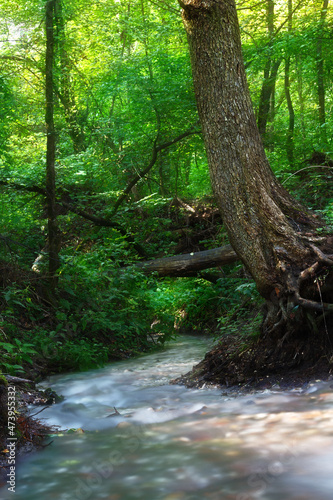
0, 0, 333, 373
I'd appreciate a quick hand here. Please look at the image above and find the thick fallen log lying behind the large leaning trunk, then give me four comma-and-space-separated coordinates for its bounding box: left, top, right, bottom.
137, 245, 239, 277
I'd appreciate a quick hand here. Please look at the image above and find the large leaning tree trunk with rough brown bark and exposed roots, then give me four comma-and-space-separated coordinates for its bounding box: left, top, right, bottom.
180, 0, 333, 376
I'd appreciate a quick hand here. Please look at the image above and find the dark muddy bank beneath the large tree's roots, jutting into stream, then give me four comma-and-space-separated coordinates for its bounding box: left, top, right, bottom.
172, 335, 333, 394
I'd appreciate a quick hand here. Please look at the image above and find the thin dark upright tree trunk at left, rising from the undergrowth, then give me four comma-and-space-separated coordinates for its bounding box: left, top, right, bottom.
45, 0, 60, 288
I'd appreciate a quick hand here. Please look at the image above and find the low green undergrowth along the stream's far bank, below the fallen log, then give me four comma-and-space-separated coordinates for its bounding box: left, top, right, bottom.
0, 189, 333, 378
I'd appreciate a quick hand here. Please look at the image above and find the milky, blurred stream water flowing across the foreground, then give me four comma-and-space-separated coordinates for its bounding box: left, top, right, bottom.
0, 337, 333, 500
